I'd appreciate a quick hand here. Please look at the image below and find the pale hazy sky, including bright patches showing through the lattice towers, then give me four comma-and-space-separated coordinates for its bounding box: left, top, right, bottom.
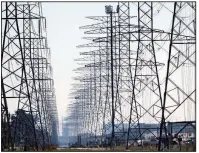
0, 2, 194, 137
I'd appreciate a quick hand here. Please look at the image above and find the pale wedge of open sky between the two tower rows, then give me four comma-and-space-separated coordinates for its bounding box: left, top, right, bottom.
42, 2, 117, 120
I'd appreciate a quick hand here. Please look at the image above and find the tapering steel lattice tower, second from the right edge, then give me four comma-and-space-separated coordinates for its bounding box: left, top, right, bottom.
127, 2, 164, 148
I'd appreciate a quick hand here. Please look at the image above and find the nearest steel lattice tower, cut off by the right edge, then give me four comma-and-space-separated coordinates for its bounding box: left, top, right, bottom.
158, 2, 196, 150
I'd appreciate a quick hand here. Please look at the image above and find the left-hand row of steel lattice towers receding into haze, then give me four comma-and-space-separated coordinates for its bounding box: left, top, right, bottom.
1, 2, 58, 151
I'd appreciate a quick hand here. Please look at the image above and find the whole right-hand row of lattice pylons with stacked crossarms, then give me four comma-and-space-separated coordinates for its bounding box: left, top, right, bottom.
65, 2, 196, 150
